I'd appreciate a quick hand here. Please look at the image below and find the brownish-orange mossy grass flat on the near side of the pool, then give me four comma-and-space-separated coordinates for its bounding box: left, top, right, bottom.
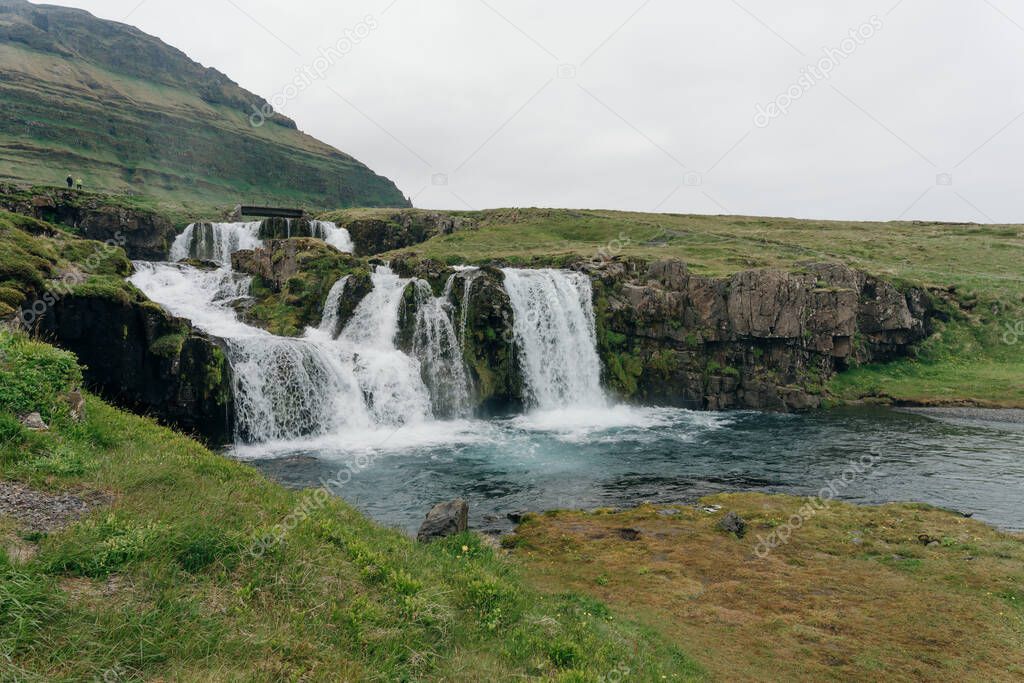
509, 494, 1024, 681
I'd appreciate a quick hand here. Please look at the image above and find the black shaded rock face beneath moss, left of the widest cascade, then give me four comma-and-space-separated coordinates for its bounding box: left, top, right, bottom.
36, 294, 233, 445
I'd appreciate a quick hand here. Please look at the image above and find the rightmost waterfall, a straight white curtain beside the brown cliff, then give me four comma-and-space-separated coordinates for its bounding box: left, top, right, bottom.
503, 268, 606, 410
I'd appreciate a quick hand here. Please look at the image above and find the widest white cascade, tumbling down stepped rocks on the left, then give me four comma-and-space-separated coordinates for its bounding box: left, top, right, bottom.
131, 262, 433, 442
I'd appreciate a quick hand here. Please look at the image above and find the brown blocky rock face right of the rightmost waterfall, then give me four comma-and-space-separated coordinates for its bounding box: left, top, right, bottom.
578, 260, 936, 411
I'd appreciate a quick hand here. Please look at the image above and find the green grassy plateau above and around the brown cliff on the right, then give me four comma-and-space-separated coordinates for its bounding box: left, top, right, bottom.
354, 209, 1024, 408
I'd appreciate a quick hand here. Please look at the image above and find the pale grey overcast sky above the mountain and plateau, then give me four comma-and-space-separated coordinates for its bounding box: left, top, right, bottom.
51, 0, 1024, 222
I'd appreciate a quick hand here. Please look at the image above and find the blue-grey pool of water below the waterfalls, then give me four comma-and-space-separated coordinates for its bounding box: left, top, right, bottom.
233, 407, 1024, 531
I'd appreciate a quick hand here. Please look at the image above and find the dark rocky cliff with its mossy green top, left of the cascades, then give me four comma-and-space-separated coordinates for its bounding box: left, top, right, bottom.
0, 210, 232, 443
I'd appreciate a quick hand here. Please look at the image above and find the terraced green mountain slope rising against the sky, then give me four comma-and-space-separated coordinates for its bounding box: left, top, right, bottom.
0, 0, 408, 209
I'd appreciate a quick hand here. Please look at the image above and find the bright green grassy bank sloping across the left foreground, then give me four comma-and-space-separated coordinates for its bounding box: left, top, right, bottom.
0, 333, 703, 681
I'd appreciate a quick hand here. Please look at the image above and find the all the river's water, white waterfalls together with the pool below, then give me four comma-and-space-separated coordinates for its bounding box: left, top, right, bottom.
131, 223, 1024, 529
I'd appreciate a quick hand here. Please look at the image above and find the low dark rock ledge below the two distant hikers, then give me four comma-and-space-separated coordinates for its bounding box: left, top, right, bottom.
0, 184, 175, 261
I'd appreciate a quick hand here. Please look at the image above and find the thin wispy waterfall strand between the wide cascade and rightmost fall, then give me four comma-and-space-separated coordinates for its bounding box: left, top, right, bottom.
413, 275, 470, 417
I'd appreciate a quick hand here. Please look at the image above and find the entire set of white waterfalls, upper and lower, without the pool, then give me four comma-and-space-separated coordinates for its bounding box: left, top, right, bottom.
131, 242, 605, 443
